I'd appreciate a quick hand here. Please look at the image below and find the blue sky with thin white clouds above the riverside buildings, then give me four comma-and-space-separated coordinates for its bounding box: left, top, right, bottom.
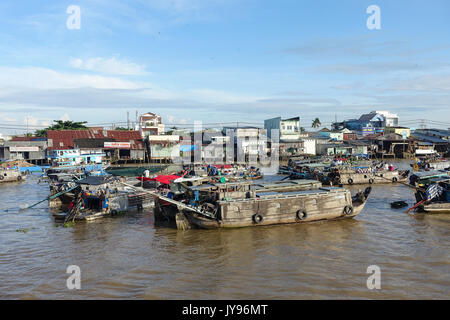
0, 0, 450, 134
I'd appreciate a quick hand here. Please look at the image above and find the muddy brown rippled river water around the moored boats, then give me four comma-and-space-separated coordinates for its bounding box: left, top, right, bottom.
0, 164, 450, 299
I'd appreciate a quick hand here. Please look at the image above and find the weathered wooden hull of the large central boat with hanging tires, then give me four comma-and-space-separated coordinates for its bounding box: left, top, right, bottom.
184, 190, 370, 229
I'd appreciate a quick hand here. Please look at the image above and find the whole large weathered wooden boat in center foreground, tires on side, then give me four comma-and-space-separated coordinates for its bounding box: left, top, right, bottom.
155, 180, 371, 229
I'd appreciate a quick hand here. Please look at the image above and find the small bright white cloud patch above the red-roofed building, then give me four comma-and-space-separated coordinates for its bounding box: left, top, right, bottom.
69, 57, 147, 76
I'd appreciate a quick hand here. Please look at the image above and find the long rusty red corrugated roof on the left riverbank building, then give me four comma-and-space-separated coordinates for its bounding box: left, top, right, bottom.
47, 129, 145, 150
